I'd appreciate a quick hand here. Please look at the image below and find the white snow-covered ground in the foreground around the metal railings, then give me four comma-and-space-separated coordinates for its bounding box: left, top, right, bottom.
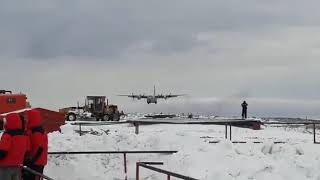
45, 117, 320, 180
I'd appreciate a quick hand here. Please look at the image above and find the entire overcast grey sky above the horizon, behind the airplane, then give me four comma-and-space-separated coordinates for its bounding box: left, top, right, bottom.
0, 0, 320, 117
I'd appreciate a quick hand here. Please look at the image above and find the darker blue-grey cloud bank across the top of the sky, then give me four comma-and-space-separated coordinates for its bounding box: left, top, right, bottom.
0, 0, 319, 59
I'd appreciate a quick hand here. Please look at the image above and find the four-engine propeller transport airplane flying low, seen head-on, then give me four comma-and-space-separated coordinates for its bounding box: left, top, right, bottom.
118, 86, 186, 104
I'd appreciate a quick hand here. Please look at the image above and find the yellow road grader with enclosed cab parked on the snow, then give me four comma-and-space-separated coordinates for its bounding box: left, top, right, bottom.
59, 96, 123, 121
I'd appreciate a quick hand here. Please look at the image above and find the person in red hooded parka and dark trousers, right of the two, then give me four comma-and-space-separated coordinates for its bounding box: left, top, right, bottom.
24, 110, 48, 180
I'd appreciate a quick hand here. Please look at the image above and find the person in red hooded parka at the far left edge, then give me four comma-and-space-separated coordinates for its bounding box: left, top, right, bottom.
0, 113, 28, 180
